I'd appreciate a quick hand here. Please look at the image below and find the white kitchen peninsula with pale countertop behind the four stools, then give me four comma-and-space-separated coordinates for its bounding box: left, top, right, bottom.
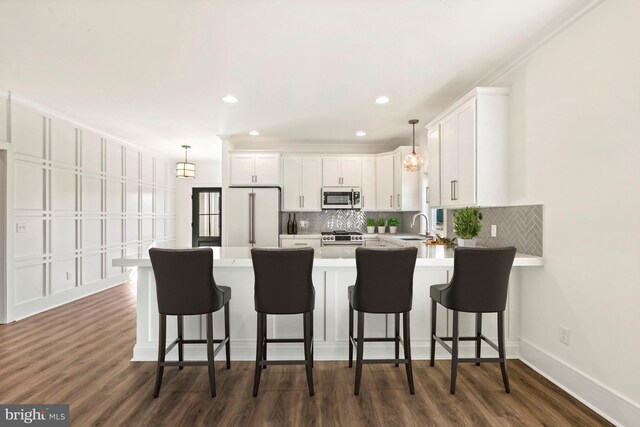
113, 249, 544, 361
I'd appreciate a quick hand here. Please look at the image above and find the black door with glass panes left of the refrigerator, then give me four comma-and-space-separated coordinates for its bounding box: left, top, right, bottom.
191, 187, 222, 247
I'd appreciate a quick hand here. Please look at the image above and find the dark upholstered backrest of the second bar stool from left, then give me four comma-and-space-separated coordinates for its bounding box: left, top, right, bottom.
251, 248, 315, 314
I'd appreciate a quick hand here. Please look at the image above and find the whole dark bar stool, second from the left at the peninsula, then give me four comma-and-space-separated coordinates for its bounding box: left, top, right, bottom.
251, 248, 316, 397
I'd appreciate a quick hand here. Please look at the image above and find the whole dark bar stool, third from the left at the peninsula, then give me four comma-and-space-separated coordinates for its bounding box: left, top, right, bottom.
349, 247, 418, 396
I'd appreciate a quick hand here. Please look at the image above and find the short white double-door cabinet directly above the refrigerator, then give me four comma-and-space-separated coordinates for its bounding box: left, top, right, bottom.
229, 153, 280, 186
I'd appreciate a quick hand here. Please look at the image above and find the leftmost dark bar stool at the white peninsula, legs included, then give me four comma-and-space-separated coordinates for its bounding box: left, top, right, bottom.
149, 248, 231, 397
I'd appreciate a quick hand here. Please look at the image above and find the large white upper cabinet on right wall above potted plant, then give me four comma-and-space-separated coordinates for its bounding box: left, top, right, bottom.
426, 88, 509, 207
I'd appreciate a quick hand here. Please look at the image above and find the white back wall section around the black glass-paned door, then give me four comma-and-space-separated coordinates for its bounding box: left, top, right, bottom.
175, 160, 224, 247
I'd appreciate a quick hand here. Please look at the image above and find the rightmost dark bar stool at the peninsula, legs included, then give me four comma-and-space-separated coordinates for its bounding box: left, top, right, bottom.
430, 247, 516, 394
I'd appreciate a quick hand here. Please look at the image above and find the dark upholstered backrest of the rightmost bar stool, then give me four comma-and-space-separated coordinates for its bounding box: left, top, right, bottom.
442, 246, 516, 313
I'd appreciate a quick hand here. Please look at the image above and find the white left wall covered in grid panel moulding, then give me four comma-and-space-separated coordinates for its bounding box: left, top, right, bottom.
5, 98, 175, 321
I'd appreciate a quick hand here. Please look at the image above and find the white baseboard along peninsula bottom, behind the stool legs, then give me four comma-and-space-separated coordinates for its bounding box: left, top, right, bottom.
131, 338, 518, 362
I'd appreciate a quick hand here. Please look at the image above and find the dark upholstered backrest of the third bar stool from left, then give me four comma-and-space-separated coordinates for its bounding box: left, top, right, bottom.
352, 247, 418, 313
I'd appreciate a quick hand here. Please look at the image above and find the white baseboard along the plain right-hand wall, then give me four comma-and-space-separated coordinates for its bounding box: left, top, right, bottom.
520, 338, 640, 427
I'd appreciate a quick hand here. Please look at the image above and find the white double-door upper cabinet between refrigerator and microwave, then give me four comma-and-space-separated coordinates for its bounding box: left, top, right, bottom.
282, 156, 322, 211
